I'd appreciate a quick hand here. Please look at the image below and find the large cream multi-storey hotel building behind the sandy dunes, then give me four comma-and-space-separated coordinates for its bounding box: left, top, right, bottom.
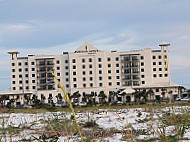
0, 42, 180, 104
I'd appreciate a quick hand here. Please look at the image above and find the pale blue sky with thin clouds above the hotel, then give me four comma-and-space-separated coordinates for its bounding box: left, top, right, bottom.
0, 0, 190, 91
